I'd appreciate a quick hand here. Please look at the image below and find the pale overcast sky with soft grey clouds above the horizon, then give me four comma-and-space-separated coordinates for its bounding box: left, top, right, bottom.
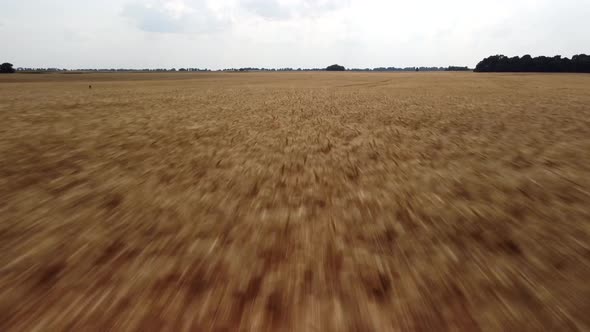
0, 0, 590, 69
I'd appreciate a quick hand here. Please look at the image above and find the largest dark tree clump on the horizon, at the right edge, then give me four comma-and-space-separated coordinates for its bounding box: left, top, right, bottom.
475, 54, 590, 73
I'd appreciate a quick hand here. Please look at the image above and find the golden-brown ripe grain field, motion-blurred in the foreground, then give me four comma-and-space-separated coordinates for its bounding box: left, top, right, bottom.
0, 72, 590, 331
